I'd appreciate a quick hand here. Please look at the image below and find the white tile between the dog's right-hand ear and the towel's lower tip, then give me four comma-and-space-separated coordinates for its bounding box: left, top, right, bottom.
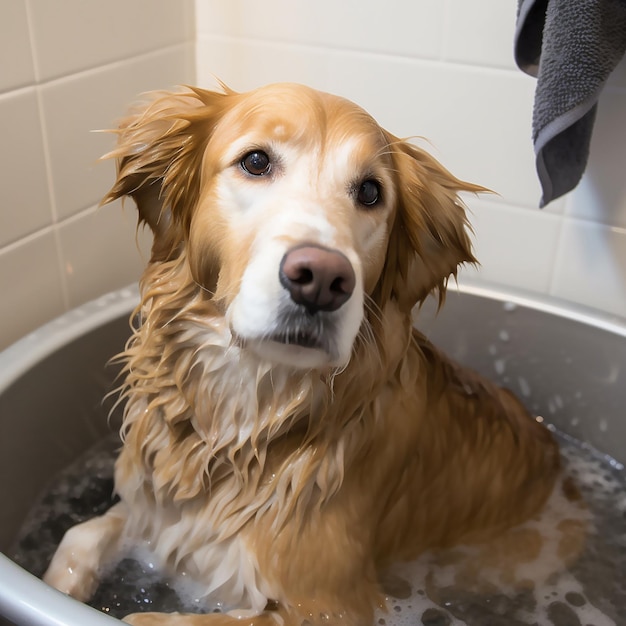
459, 199, 562, 293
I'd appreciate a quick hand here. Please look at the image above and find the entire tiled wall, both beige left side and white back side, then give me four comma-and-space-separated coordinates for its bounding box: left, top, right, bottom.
0, 0, 626, 348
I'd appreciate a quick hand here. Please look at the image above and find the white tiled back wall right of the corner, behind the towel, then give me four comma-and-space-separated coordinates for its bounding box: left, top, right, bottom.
196, 0, 626, 316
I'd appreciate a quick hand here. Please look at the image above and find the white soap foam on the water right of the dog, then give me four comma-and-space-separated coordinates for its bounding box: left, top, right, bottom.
375, 432, 626, 626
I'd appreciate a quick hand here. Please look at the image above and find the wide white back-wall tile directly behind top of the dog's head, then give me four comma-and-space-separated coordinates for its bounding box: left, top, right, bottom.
196, 36, 544, 212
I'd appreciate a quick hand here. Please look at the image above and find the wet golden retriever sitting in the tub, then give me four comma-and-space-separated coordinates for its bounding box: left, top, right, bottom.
44, 84, 559, 626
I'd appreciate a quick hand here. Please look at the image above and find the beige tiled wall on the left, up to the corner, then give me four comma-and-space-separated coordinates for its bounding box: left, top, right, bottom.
0, 0, 195, 348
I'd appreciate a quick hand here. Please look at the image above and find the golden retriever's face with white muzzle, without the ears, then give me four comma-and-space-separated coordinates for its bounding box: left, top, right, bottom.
189, 85, 395, 368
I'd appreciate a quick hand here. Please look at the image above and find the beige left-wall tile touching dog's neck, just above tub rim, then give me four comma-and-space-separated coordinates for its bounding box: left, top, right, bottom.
59, 200, 152, 307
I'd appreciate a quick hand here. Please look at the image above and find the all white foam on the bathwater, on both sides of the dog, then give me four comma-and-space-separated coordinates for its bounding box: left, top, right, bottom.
11, 429, 626, 626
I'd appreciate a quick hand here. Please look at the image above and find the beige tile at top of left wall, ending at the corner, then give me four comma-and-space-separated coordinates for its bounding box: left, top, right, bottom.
30, 0, 193, 81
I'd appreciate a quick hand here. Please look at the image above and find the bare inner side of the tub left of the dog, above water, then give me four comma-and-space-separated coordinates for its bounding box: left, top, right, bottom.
0, 316, 129, 551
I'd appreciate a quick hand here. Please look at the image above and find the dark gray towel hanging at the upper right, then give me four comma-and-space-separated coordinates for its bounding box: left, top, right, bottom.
515, 0, 626, 207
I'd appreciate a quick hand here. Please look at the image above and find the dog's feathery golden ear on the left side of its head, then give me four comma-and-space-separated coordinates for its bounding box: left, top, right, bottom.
102, 85, 234, 261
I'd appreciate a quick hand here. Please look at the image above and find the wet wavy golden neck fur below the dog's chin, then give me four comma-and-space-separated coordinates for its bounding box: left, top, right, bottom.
114, 251, 410, 516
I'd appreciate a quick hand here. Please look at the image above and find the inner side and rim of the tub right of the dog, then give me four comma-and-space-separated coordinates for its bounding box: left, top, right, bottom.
416, 288, 626, 463
